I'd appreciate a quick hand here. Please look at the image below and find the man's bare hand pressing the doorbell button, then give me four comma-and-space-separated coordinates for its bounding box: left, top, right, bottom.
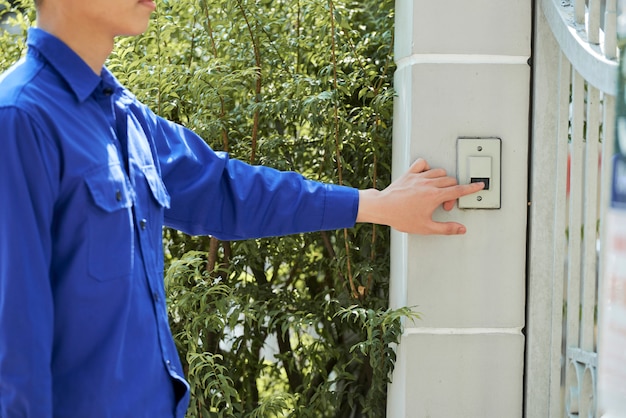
356, 158, 484, 235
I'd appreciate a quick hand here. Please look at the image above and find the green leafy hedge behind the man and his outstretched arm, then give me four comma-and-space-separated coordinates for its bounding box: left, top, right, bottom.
0, 0, 416, 418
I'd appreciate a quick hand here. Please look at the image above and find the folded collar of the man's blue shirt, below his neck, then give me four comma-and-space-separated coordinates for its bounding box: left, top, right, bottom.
27, 28, 110, 102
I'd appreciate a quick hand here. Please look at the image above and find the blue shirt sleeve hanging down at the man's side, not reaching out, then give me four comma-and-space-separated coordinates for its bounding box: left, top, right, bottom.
0, 107, 58, 418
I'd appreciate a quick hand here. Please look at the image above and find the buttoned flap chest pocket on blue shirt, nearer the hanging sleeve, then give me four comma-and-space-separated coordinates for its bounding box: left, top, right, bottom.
85, 165, 135, 281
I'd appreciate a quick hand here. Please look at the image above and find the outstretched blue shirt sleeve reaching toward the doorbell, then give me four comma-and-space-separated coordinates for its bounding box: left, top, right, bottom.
154, 118, 358, 240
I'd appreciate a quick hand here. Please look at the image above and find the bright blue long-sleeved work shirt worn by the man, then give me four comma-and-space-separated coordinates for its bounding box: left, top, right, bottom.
0, 29, 358, 418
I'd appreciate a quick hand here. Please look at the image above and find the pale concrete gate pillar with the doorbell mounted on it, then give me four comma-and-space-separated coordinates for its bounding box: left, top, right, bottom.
388, 0, 532, 418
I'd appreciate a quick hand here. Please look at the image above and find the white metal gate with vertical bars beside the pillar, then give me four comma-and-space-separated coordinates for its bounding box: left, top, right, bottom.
525, 0, 617, 418
